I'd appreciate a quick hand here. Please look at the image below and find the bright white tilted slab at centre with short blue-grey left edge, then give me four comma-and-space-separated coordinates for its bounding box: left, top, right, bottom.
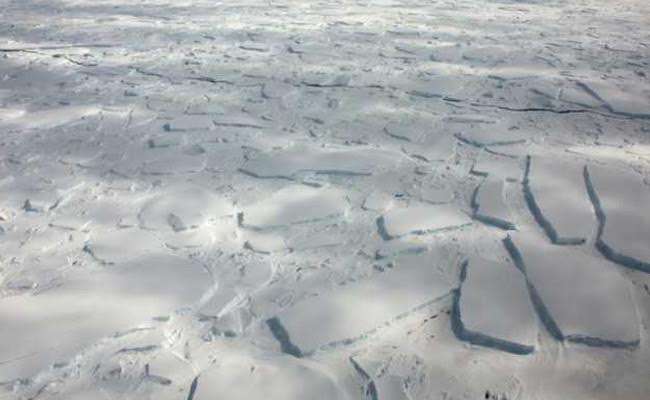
240, 185, 348, 228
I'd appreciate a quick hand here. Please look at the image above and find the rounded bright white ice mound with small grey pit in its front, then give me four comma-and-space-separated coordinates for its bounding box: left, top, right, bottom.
138, 185, 234, 232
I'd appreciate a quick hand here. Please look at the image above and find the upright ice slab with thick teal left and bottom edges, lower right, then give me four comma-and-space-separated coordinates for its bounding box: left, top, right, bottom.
452, 257, 537, 354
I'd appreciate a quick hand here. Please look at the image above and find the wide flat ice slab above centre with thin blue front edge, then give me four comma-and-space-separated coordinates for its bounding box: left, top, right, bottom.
240, 146, 401, 179
